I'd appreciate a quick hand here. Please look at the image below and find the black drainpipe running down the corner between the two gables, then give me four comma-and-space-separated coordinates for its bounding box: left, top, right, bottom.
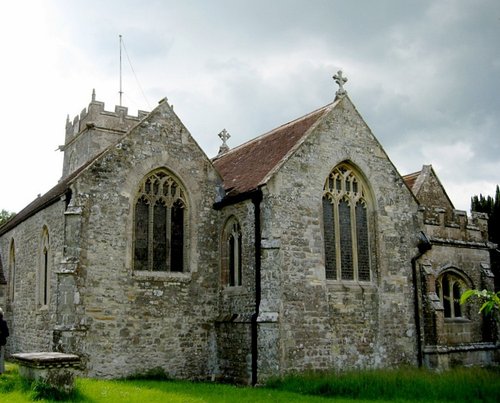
251, 189, 262, 386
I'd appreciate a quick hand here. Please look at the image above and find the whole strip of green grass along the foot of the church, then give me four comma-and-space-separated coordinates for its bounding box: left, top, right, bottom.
0, 363, 500, 403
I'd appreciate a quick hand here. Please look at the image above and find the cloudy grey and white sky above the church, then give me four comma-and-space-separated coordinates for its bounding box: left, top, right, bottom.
0, 0, 500, 215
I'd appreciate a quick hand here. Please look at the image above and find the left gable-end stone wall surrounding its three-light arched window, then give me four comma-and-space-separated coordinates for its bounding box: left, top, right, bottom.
62, 102, 222, 379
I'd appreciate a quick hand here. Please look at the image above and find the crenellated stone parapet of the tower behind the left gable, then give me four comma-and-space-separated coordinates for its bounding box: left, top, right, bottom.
65, 91, 149, 146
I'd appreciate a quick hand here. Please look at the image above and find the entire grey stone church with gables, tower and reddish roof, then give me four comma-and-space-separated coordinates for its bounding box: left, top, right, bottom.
0, 72, 499, 384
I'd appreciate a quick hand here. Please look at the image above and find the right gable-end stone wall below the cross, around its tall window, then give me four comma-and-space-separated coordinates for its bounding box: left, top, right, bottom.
259, 99, 417, 376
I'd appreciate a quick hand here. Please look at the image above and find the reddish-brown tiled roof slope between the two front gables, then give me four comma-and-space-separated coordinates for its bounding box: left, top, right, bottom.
213, 104, 333, 197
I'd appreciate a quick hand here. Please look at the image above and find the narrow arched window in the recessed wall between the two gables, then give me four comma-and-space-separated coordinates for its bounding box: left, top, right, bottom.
221, 217, 242, 287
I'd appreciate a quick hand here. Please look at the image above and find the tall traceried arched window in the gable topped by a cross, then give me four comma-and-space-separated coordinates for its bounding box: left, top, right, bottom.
323, 164, 370, 281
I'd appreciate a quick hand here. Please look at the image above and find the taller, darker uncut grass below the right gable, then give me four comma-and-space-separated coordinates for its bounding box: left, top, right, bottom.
267, 368, 500, 402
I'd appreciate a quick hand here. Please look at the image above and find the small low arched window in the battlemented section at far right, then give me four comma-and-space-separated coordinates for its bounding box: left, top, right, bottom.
436, 271, 468, 318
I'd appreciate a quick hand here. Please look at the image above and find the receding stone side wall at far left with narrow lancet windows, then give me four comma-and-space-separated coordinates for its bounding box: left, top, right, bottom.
0, 200, 65, 354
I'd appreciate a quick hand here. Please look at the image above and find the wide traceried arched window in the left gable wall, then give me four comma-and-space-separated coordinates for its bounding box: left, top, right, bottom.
134, 169, 187, 272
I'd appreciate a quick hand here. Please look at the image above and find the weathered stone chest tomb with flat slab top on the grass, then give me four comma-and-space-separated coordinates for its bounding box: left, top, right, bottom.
11, 352, 80, 393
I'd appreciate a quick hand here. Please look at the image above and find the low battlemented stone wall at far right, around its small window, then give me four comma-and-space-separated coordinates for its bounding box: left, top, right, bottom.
419, 209, 498, 369
